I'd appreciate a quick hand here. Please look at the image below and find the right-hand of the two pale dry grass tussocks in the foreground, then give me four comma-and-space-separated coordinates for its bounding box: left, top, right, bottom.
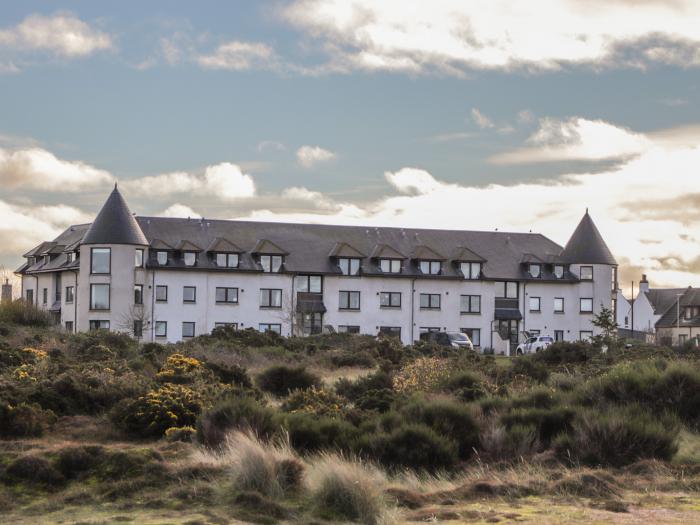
309, 454, 385, 525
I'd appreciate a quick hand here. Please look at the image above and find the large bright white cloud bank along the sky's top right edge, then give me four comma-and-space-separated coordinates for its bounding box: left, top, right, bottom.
281, 0, 700, 74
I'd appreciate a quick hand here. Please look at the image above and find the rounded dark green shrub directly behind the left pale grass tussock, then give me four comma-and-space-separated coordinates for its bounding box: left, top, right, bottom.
197, 396, 279, 447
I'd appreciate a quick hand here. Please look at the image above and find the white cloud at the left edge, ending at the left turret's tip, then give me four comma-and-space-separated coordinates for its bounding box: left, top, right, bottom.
0, 148, 114, 192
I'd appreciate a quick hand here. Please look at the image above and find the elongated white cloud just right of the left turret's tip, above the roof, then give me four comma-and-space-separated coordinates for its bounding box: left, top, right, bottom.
123, 162, 255, 201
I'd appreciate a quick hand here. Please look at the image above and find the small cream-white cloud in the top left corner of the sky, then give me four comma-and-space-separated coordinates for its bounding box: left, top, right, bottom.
0, 13, 114, 58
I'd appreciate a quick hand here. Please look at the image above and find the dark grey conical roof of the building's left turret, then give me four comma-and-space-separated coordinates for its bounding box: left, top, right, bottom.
82, 184, 148, 245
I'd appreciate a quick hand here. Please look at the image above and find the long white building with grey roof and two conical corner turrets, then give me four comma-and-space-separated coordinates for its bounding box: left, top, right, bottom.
17, 186, 617, 353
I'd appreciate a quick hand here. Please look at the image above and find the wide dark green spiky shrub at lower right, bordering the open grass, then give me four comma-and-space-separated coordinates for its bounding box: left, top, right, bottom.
555, 406, 679, 467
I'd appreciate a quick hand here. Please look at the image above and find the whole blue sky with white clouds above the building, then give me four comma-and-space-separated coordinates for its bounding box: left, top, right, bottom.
0, 0, 700, 287
